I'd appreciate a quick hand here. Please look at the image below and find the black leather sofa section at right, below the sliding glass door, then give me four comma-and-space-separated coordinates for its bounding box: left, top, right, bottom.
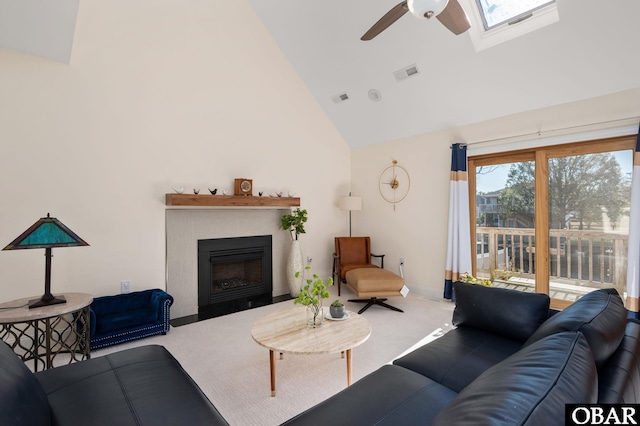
285, 283, 640, 426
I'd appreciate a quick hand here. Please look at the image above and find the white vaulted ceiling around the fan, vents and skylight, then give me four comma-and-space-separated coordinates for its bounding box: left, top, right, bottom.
0, 0, 640, 147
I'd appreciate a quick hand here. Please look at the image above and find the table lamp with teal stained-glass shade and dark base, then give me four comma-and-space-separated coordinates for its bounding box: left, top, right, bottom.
3, 213, 89, 308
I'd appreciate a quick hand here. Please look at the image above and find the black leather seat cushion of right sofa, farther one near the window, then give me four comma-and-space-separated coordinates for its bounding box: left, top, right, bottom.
393, 326, 522, 392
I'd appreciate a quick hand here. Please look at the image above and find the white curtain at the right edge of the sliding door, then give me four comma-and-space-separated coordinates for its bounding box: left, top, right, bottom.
627, 129, 640, 318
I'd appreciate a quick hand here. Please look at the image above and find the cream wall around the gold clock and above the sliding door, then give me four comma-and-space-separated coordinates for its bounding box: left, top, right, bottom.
351, 89, 640, 297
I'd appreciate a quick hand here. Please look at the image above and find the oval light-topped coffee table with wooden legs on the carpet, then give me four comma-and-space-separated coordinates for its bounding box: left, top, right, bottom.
251, 307, 371, 396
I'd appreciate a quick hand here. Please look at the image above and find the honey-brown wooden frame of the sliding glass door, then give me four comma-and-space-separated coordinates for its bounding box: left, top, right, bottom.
467, 135, 637, 309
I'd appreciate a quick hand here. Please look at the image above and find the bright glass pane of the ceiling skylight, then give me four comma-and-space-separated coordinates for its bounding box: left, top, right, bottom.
476, 0, 555, 31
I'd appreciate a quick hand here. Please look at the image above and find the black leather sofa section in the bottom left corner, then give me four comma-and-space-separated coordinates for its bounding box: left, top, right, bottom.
0, 342, 228, 426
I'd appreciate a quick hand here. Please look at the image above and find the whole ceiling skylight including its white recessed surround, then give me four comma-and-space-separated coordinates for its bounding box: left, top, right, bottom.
458, 0, 560, 52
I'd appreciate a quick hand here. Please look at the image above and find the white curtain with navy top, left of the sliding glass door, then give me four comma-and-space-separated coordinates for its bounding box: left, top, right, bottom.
444, 144, 471, 300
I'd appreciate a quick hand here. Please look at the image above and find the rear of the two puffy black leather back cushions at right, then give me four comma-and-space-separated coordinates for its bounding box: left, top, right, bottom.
525, 288, 627, 367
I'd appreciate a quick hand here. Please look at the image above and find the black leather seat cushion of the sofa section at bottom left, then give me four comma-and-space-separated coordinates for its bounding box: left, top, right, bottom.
35, 345, 227, 426
